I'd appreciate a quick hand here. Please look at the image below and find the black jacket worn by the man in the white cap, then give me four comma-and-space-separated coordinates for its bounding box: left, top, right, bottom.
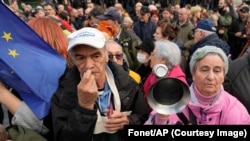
51, 62, 150, 141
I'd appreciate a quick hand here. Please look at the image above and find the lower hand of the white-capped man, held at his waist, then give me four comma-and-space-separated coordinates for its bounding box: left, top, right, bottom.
104, 111, 129, 131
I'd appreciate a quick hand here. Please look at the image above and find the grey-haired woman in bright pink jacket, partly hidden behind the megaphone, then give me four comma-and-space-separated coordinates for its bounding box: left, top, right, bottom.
143, 40, 187, 96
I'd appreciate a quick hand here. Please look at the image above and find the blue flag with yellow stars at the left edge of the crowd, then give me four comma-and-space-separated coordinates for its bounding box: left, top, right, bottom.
0, 2, 66, 119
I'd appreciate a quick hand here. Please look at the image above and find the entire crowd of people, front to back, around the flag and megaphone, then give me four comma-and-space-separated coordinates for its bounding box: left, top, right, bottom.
0, 0, 250, 141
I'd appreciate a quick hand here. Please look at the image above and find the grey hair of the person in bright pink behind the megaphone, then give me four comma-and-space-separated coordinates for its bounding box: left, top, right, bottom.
154, 40, 181, 70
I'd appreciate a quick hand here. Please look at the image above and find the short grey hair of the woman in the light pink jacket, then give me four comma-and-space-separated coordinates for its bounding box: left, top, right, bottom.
189, 46, 228, 75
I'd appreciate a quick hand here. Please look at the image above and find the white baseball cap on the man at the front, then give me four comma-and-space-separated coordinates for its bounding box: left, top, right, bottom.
68, 27, 106, 51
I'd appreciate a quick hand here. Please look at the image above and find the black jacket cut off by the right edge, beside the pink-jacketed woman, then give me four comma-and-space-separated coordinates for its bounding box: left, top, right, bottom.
224, 54, 250, 113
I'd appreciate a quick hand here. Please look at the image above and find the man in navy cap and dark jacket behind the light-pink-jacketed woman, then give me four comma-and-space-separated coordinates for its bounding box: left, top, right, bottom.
186, 19, 230, 84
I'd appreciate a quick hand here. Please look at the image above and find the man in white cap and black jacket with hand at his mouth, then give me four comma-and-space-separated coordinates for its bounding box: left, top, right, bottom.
51, 27, 150, 141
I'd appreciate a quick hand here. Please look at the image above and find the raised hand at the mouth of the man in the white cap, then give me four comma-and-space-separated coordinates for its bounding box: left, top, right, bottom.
77, 70, 98, 109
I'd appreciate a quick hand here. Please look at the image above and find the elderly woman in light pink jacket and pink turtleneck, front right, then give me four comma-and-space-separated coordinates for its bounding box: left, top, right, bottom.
146, 46, 250, 125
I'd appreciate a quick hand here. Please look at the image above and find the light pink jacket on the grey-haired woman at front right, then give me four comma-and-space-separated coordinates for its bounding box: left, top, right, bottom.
145, 86, 250, 125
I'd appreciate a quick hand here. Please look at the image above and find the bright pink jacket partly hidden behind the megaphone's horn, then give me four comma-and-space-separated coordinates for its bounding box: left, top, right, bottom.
143, 65, 188, 97
